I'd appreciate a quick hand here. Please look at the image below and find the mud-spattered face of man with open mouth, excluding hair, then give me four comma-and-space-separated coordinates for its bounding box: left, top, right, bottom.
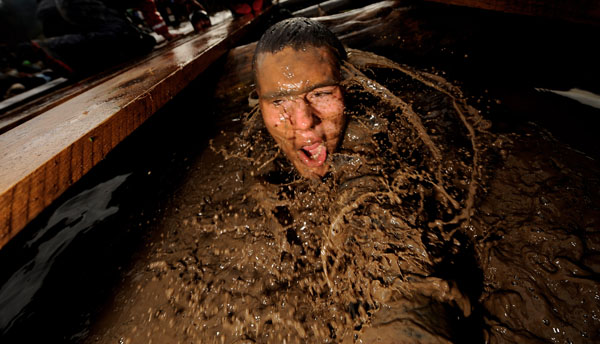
256, 47, 345, 178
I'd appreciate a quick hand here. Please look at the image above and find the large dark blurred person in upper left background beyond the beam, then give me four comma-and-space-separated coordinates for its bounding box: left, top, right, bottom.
17, 0, 175, 75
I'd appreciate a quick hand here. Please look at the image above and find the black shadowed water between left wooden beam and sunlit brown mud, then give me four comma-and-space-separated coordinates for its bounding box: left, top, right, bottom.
0, 56, 230, 343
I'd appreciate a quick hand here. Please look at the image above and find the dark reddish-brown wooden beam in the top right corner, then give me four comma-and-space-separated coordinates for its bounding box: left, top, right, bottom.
426, 0, 600, 25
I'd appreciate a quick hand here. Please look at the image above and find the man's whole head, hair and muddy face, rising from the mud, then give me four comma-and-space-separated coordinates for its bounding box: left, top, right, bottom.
253, 18, 346, 178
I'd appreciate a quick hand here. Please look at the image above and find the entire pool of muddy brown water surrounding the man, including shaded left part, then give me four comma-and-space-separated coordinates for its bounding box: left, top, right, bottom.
0, 3, 600, 343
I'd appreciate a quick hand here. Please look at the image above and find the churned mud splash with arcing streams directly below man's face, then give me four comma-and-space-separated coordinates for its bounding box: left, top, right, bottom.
204, 47, 488, 342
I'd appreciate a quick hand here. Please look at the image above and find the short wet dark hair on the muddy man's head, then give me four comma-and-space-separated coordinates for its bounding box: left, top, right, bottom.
252, 17, 347, 75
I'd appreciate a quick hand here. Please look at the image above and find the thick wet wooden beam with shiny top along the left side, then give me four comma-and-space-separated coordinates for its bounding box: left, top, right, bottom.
0, 10, 268, 248
